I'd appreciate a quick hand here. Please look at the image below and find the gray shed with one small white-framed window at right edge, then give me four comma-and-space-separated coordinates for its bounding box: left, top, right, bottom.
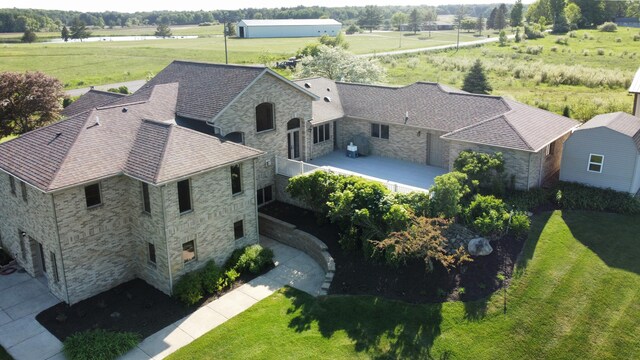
560, 112, 640, 194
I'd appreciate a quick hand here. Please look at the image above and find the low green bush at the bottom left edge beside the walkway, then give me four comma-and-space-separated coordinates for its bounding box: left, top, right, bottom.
63, 329, 141, 360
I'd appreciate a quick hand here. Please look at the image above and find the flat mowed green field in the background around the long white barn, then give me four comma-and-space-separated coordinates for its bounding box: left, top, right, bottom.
0, 26, 476, 89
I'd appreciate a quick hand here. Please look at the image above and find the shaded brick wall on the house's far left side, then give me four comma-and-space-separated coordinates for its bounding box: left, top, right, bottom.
0, 172, 67, 301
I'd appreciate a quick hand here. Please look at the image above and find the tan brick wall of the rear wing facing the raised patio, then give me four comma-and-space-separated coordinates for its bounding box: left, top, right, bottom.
337, 117, 449, 167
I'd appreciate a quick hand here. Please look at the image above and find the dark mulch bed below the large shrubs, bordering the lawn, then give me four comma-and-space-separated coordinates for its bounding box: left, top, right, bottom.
260, 202, 524, 303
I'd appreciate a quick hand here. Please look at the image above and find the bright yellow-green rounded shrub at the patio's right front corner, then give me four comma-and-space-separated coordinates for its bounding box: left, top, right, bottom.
430, 171, 470, 218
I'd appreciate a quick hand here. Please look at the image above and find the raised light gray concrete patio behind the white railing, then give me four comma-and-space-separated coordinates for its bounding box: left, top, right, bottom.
309, 151, 448, 189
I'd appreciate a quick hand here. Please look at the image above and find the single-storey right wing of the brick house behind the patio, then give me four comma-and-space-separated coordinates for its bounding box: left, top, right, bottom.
296, 78, 578, 189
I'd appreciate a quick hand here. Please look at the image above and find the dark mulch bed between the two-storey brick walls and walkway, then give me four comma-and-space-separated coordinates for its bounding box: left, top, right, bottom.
36, 269, 270, 341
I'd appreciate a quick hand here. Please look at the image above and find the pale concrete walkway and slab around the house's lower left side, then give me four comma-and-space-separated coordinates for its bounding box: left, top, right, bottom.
0, 237, 325, 360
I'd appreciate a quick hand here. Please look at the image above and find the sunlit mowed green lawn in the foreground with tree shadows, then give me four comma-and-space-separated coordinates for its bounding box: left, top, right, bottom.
169, 211, 640, 359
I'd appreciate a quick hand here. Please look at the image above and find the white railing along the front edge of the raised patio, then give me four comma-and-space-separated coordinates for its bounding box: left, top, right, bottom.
276, 156, 428, 194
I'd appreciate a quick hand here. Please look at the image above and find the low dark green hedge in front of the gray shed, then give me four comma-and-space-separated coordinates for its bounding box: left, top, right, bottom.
554, 182, 640, 214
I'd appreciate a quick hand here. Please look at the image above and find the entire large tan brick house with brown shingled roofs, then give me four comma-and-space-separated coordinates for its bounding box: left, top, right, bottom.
0, 61, 577, 304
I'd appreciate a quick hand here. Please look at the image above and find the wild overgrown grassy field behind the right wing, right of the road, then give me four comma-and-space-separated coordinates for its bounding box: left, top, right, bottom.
382, 28, 640, 120
